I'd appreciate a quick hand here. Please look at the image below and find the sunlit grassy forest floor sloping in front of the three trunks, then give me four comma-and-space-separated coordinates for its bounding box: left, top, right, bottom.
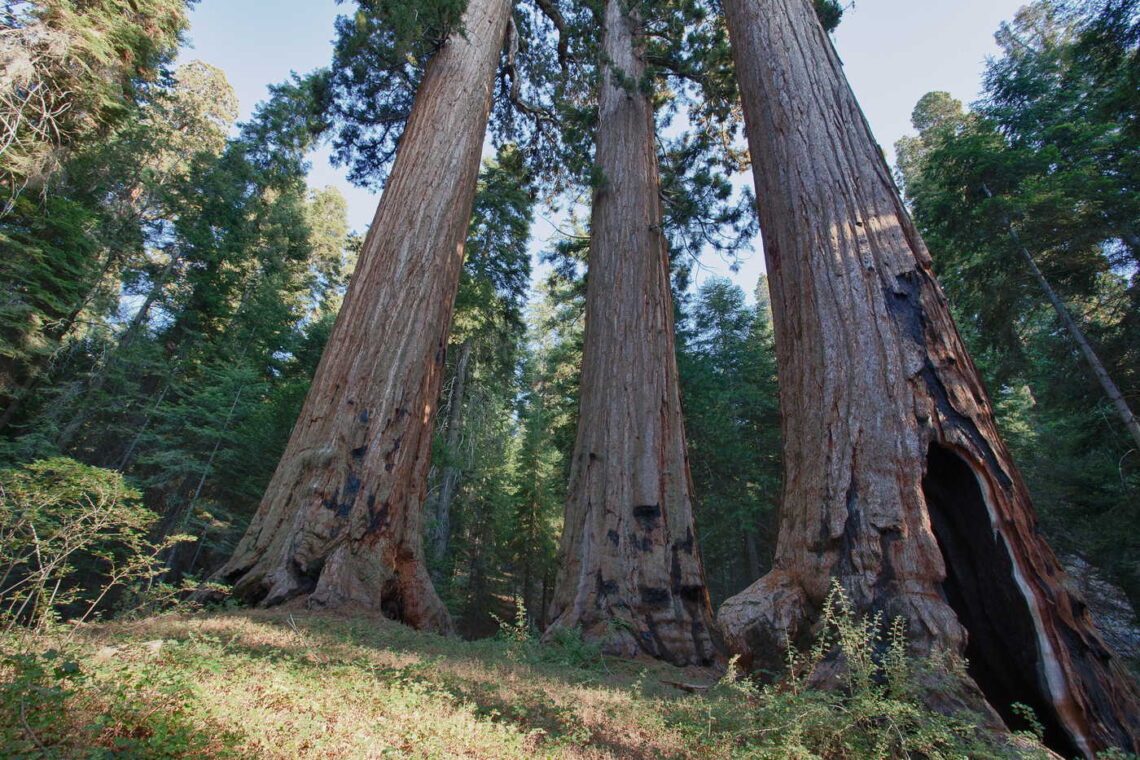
0, 610, 1057, 760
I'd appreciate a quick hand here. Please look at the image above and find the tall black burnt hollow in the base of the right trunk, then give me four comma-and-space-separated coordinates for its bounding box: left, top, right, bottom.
922, 444, 1081, 758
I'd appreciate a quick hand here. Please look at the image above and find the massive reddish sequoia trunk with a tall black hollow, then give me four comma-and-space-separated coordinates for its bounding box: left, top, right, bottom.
719, 0, 1140, 757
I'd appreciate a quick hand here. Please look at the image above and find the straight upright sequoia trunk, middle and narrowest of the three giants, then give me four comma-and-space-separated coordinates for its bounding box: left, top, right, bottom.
538, 0, 716, 664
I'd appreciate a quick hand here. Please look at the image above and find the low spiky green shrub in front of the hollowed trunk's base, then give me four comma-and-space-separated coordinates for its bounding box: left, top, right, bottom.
674, 586, 1050, 760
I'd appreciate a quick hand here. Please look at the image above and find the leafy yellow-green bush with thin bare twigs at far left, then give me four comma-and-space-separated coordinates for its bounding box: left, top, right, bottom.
0, 458, 186, 630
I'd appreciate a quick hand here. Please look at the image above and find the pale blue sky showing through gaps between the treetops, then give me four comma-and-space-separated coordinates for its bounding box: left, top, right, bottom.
182, 0, 1025, 293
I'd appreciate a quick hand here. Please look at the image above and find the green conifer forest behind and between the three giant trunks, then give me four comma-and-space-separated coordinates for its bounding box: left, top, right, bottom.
0, 0, 1140, 757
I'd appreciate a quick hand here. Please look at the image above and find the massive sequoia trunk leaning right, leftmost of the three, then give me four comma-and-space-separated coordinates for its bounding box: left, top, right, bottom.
212, 0, 511, 630
